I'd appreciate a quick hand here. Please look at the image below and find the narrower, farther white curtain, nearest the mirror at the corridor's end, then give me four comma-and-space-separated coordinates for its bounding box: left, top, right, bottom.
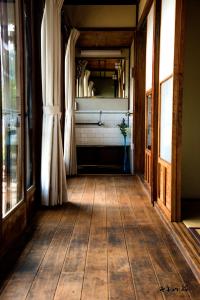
64, 29, 80, 176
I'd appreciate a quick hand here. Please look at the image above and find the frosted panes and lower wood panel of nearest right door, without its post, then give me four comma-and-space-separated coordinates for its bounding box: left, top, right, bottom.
158, 0, 176, 219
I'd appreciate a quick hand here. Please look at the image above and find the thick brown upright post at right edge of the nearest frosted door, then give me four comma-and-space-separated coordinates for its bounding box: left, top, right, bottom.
172, 0, 186, 221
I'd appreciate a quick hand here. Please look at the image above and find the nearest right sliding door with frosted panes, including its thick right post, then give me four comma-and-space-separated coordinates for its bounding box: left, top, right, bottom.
157, 0, 185, 221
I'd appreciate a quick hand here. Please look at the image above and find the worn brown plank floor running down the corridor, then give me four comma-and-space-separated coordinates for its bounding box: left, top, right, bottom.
0, 176, 200, 300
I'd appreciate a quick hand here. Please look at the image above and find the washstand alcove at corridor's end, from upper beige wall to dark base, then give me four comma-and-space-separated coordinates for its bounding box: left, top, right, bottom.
64, 4, 136, 174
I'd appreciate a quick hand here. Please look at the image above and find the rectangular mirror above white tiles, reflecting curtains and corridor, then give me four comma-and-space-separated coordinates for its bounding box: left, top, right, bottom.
76, 57, 129, 98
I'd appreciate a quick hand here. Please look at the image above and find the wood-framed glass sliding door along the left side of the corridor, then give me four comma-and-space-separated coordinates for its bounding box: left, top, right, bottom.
0, 0, 35, 253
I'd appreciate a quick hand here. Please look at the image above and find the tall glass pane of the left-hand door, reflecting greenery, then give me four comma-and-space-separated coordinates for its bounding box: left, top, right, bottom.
0, 0, 22, 216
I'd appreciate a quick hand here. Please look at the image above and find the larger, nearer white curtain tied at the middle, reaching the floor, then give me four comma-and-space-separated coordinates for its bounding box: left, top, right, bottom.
41, 0, 67, 206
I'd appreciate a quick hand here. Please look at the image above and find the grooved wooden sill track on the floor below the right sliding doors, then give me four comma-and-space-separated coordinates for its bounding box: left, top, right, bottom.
155, 203, 200, 283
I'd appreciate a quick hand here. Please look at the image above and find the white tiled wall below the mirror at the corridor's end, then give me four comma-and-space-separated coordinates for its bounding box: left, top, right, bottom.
75, 98, 132, 145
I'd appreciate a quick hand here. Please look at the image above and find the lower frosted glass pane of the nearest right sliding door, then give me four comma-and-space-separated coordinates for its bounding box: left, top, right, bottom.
160, 78, 173, 163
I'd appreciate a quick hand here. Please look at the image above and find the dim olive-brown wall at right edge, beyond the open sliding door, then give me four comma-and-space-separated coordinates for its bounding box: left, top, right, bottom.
182, 0, 200, 199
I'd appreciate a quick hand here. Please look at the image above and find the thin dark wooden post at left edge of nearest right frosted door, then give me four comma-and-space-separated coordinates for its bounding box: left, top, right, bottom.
151, 0, 161, 203
